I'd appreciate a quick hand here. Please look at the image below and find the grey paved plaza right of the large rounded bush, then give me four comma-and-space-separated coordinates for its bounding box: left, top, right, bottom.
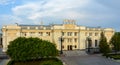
61, 52, 120, 65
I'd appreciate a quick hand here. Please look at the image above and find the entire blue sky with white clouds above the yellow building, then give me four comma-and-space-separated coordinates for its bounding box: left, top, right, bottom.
0, 0, 120, 31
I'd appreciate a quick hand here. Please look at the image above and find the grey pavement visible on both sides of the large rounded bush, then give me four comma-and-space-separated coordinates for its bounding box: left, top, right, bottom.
0, 48, 120, 65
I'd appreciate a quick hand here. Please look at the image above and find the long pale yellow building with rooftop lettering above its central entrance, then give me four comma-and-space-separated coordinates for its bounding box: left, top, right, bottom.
2, 20, 114, 52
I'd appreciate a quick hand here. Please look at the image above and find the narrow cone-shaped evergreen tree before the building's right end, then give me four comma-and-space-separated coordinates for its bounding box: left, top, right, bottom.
99, 32, 110, 55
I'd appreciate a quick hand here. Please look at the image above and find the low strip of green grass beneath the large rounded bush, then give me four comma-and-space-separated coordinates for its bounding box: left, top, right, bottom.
8, 58, 63, 65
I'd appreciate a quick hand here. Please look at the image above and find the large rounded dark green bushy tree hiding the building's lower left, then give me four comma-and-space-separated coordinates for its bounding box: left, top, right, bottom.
7, 37, 58, 61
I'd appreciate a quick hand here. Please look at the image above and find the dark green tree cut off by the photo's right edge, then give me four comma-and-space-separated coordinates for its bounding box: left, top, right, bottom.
110, 32, 120, 53
